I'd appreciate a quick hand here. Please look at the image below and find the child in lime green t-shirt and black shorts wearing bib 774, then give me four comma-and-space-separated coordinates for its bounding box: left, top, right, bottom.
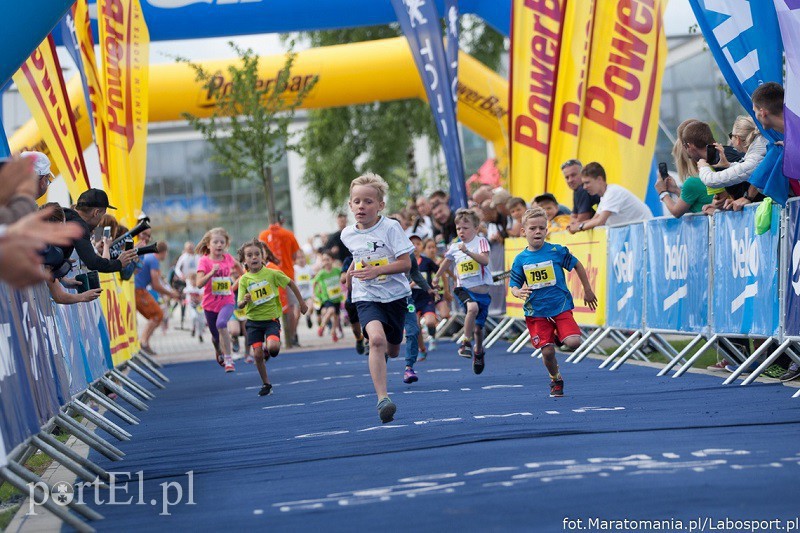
237, 239, 308, 396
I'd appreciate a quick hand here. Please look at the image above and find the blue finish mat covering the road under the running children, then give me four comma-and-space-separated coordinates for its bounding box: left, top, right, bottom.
79, 345, 800, 531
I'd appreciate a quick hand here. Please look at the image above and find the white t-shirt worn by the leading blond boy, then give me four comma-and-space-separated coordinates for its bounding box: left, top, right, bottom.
341, 217, 414, 302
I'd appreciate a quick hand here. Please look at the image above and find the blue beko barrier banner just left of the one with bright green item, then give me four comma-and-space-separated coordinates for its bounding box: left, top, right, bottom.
645, 215, 709, 333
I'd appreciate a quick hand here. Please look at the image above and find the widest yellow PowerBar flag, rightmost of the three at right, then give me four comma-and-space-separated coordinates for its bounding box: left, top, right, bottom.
578, 0, 667, 199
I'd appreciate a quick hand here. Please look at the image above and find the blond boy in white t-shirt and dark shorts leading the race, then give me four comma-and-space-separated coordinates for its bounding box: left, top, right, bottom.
341, 173, 414, 424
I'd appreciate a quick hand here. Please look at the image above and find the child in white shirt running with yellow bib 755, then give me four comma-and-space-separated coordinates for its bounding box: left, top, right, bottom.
436, 209, 493, 374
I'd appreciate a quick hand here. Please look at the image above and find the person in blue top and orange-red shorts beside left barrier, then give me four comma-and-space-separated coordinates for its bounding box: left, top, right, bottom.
133, 242, 181, 355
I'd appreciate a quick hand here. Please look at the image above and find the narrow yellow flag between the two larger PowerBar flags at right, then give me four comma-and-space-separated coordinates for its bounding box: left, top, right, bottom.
546, 0, 596, 207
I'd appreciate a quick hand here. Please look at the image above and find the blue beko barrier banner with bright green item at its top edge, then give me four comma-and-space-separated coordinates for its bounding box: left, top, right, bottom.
712, 205, 780, 336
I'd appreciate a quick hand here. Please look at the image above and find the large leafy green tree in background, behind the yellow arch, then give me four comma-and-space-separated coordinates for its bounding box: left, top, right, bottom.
301, 20, 504, 209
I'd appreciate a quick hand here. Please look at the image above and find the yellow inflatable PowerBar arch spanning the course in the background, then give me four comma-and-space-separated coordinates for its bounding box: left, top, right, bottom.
9, 37, 508, 180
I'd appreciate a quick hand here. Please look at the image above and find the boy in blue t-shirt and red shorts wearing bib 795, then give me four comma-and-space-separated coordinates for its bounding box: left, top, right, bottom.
509, 207, 597, 398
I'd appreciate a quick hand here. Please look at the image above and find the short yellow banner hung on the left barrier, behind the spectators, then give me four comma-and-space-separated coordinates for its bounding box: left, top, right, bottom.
100, 274, 139, 366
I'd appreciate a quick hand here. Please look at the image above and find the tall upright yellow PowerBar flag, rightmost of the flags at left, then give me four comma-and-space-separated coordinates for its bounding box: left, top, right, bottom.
97, 0, 150, 227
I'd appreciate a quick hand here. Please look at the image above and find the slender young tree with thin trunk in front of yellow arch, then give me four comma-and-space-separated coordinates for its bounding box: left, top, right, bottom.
176, 41, 317, 224
